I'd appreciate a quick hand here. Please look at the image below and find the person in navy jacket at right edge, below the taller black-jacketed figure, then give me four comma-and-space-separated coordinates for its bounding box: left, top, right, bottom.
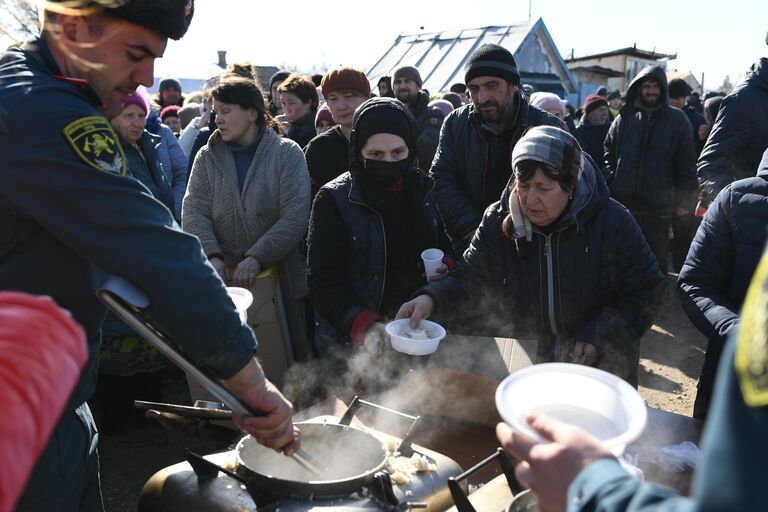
679, 146, 768, 419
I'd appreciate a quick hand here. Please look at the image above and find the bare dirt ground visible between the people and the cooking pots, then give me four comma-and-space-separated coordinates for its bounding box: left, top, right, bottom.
99, 278, 706, 512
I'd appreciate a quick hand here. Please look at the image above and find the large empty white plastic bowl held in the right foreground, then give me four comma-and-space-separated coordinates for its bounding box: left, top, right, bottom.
496, 363, 647, 456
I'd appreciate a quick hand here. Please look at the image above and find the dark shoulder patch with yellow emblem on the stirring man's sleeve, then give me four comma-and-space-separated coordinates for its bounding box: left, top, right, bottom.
63, 116, 128, 176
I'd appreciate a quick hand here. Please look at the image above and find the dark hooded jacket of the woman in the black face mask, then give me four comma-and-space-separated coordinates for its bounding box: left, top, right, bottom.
307, 98, 450, 353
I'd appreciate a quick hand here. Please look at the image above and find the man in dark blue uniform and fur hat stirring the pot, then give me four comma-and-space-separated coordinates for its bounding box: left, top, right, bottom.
0, 0, 298, 511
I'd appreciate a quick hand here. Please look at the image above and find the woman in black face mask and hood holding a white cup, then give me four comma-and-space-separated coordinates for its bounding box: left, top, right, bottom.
308, 98, 452, 356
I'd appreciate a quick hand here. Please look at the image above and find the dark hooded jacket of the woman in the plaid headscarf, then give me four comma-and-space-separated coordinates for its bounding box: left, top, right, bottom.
422, 158, 665, 385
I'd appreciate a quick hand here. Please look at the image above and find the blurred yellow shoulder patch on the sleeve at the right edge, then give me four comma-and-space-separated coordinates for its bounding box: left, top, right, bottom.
734, 251, 768, 407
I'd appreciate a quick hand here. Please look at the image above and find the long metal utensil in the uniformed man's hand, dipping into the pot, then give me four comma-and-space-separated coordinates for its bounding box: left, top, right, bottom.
96, 276, 328, 479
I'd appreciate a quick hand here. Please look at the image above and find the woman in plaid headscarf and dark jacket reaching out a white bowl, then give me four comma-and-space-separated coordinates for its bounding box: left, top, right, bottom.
397, 126, 665, 386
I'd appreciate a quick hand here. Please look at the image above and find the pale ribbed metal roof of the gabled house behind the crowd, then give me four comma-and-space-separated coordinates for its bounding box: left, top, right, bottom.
367, 19, 577, 92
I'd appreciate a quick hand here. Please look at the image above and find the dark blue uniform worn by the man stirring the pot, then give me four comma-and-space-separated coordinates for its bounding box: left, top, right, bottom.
0, 40, 255, 508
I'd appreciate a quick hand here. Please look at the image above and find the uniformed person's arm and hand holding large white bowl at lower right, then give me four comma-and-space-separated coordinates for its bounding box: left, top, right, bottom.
496, 247, 768, 512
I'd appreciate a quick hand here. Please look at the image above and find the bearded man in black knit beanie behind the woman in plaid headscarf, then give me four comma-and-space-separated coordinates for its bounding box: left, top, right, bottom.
430, 44, 566, 251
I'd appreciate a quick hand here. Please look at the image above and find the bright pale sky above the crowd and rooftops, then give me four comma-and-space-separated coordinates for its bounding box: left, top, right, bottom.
156, 0, 768, 89
